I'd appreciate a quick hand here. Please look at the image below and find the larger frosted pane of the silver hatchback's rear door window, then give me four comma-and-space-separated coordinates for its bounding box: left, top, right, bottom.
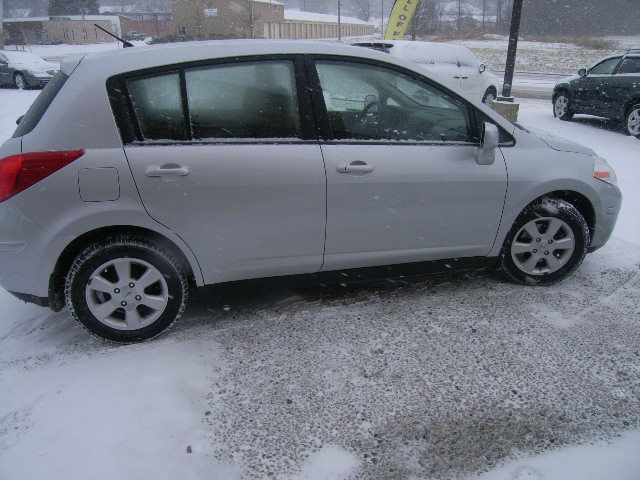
185, 62, 300, 139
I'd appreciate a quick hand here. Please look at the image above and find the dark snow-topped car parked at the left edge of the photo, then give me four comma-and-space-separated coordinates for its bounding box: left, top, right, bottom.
0, 50, 60, 90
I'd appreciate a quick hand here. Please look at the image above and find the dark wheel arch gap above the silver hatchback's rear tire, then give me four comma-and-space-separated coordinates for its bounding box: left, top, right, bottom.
49, 225, 200, 311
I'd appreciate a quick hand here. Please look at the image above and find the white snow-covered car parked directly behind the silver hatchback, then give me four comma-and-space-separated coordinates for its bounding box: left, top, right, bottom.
354, 40, 499, 103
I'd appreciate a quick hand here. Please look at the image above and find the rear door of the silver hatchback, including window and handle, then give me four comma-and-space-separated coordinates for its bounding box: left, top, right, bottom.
117, 56, 326, 283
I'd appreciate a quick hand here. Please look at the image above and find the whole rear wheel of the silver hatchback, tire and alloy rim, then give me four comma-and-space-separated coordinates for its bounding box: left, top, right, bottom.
65, 235, 189, 343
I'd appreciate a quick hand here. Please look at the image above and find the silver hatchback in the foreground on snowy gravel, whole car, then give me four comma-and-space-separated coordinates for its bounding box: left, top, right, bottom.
0, 41, 621, 342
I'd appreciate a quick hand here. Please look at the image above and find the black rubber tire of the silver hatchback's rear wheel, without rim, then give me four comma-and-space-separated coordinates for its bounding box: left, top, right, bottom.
65, 235, 189, 343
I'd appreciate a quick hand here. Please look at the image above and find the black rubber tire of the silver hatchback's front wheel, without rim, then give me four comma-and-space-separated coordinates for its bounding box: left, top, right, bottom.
499, 198, 591, 286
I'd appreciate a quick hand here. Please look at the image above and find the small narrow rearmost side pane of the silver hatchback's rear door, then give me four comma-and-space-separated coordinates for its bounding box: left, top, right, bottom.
127, 73, 187, 140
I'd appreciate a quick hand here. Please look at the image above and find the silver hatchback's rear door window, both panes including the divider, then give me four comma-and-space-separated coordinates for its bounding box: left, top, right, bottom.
121, 61, 301, 142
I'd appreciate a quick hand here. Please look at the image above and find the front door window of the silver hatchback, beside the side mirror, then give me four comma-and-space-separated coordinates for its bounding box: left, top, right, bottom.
317, 62, 473, 142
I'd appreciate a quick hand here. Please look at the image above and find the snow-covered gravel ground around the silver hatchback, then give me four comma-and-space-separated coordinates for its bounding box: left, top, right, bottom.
0, 89, 640, 480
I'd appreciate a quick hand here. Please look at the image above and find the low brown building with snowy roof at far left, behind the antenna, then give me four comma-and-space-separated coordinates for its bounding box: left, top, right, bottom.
3, 15, 122, 44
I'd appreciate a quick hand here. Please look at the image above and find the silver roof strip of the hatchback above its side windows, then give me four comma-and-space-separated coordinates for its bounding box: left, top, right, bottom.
75, 40, 396, 75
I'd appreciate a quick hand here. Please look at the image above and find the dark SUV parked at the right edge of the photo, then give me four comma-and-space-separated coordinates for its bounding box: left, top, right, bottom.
553, 48, 640, 136
